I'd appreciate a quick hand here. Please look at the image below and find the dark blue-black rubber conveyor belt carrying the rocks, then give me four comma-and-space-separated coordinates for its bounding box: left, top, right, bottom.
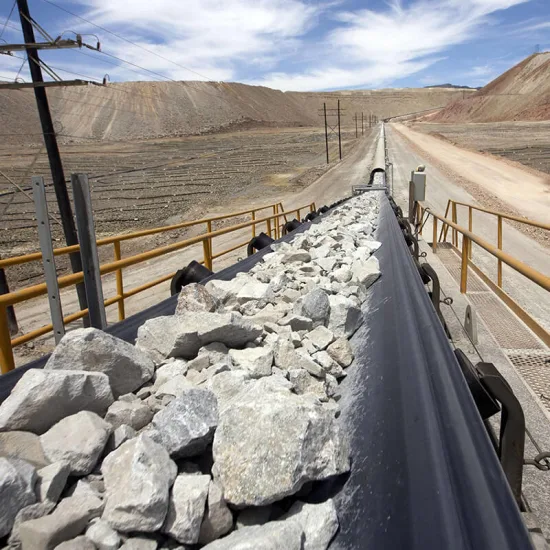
0, 193, 532, 550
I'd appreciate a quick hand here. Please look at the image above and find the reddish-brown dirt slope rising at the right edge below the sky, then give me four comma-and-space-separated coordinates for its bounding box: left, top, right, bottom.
432, 52, 550, 122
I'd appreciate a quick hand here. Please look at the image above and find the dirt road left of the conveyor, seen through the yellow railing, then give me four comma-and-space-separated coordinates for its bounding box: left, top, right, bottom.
9, 133, 377, 365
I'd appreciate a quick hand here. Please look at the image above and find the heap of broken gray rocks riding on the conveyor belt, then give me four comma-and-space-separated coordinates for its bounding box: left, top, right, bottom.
0, 194, 380, 550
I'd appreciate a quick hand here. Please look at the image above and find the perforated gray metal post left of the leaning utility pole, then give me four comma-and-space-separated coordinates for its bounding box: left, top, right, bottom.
31, 176, 65, 344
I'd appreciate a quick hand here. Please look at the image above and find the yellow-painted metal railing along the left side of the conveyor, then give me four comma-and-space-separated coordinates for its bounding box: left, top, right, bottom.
0, 201, 315, 372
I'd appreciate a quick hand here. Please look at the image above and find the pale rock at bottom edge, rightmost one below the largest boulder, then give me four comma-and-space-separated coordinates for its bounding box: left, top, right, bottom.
281, 499, 338, 550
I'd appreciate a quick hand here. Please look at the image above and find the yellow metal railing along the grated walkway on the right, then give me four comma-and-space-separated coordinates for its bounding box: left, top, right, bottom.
417, 201, 550, 346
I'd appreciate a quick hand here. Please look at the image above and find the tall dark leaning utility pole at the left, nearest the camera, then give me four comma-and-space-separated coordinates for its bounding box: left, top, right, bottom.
17, 0, 87, 325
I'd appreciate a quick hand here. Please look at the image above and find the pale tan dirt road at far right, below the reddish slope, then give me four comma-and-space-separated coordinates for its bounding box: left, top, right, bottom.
395, 124, 550, 222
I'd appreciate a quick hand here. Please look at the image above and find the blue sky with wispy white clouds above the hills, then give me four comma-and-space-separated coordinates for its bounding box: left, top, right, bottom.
0, 0, 550, 91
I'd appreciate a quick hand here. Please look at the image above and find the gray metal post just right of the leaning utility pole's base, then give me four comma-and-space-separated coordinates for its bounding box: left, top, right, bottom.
71, 174, 107, 329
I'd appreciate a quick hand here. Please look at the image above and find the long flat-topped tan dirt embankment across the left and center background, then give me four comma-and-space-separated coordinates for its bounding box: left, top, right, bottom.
0, 82, 471, 145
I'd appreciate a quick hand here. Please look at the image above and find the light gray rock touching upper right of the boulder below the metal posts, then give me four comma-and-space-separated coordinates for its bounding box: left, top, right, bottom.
136, 315, 201, 361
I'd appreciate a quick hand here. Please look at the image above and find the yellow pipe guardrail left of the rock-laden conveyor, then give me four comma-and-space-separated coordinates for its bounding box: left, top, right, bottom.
0, 202, 316, 373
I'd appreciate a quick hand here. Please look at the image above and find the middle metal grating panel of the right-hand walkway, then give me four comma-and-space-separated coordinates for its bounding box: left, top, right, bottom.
468, 292, 543, 350
